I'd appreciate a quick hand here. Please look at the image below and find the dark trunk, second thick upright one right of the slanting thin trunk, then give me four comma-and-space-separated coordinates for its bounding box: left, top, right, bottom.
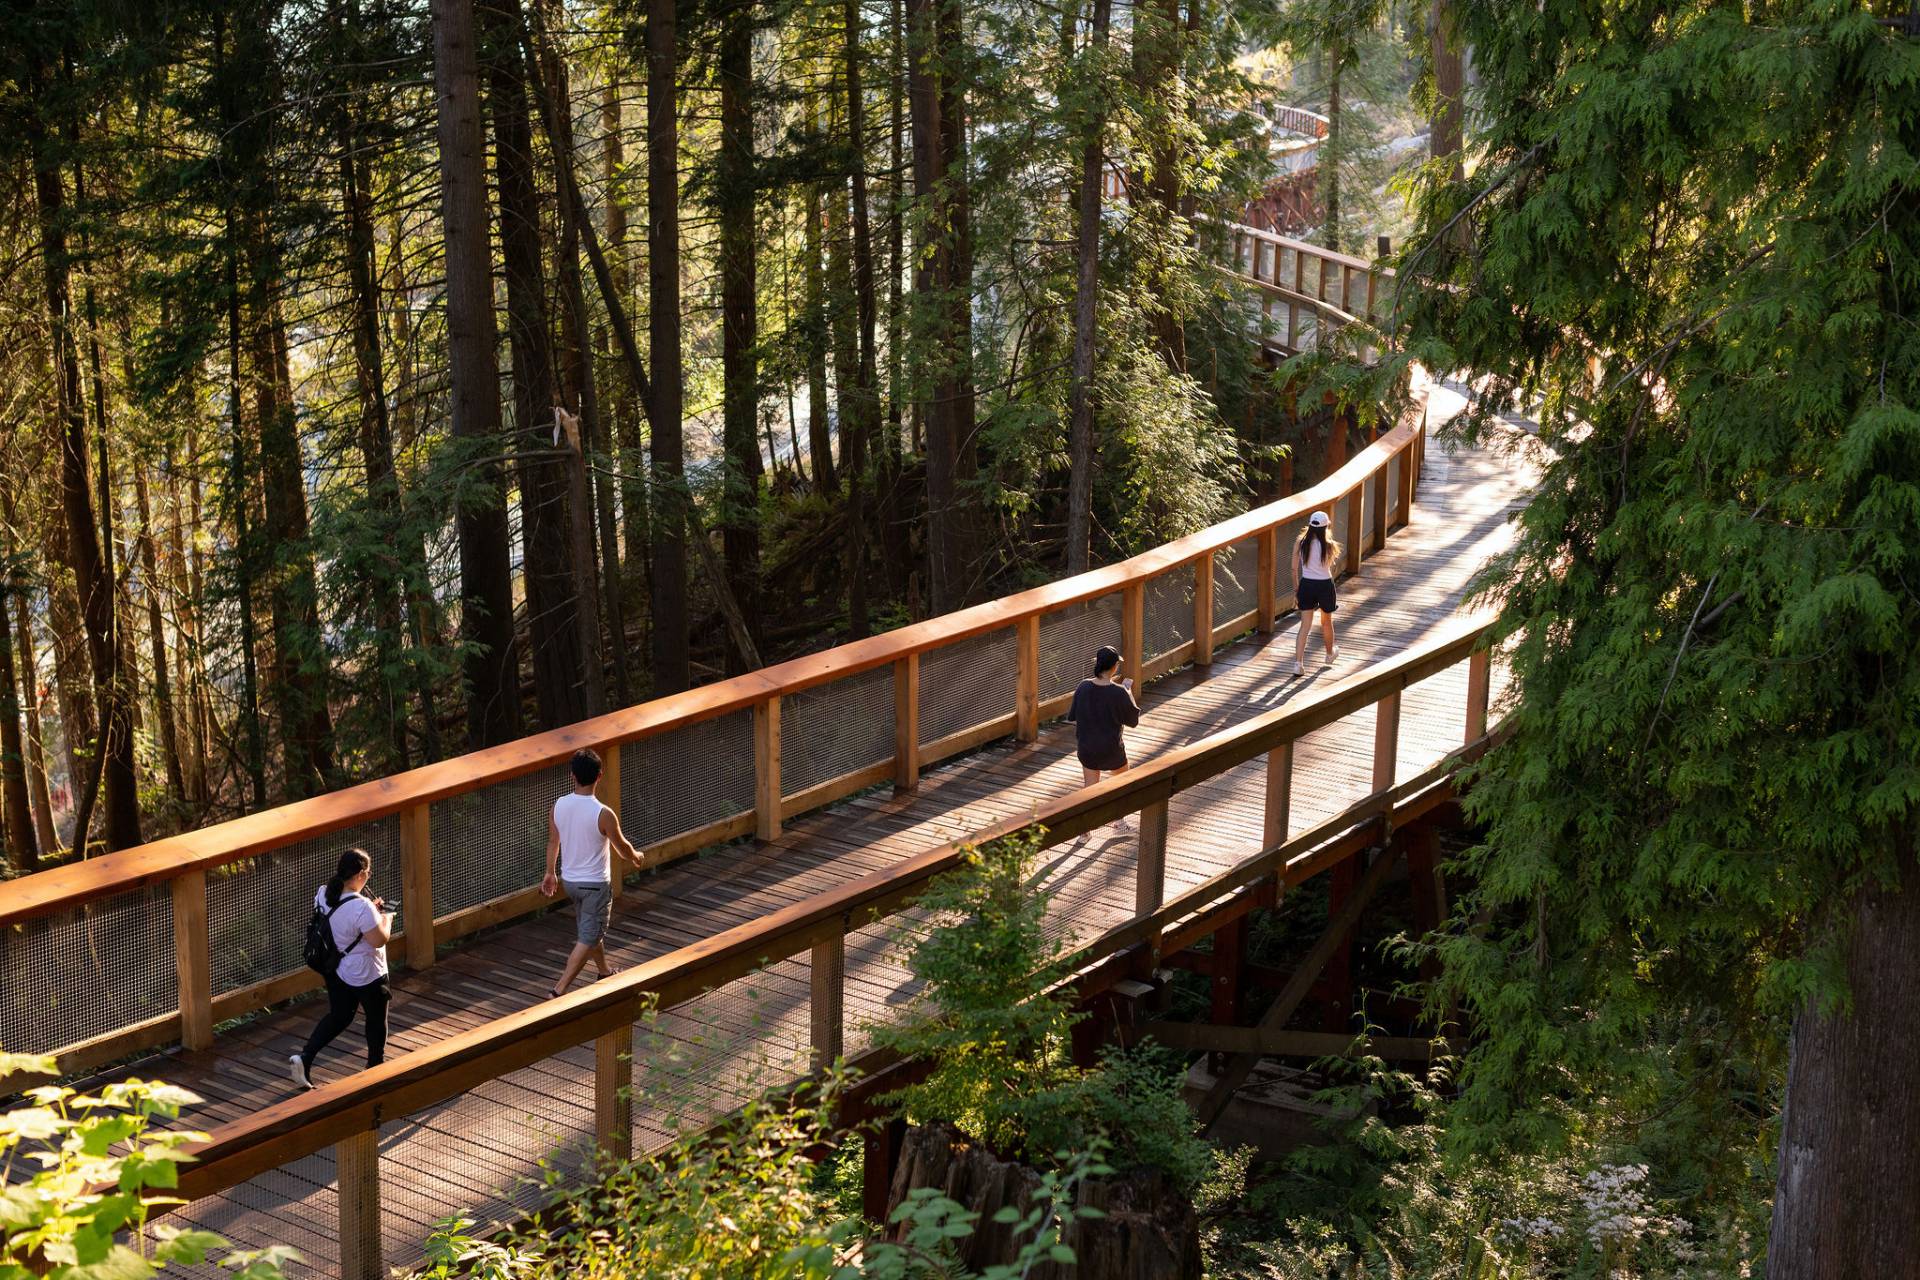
714, 4, 760, 674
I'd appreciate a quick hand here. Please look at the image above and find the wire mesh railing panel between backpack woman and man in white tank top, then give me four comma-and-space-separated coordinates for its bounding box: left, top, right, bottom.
428, 764, 574, 917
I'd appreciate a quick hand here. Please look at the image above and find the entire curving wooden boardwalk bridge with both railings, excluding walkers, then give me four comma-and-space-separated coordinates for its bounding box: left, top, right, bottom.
0, 228, 1528, 1280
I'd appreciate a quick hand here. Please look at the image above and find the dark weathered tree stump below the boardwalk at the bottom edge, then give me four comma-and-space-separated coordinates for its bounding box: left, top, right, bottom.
887, 1125, 1200, 1280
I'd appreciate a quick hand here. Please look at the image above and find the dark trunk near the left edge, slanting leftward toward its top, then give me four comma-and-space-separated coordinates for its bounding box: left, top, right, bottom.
23, 84, 140, 850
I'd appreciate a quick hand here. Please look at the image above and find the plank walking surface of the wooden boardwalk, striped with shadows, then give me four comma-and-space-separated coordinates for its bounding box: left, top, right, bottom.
97, 390, 1526, 1274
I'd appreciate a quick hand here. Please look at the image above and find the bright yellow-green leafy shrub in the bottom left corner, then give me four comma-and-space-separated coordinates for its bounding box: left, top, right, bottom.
0, 1054, 298, 1280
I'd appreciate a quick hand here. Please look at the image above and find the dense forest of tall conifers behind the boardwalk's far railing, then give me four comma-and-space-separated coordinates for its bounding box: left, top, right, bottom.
0, 0, 1427, 869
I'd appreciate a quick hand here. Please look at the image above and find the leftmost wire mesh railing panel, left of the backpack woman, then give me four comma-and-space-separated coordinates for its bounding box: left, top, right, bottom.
0, 883, 180, 1054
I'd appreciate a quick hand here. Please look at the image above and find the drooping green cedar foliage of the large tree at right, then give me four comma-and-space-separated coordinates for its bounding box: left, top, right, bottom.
1374, 0, 1920, 1251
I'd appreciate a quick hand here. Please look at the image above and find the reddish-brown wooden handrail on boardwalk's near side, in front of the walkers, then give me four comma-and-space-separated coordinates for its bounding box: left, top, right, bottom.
179, 616, 1492, 1199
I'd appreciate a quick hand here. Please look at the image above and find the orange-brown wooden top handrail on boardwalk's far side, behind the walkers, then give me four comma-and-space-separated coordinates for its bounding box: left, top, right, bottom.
0, 422, 1421, 925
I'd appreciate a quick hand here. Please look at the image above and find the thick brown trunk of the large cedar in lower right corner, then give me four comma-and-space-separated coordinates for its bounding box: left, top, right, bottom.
1766, 867, 1920, 1280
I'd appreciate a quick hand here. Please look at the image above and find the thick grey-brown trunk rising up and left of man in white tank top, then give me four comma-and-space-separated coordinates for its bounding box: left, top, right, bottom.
432, 0, 520, 747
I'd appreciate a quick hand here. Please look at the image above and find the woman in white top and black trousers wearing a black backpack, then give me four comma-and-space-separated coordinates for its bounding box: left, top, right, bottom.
288, 848, 394, 1088
